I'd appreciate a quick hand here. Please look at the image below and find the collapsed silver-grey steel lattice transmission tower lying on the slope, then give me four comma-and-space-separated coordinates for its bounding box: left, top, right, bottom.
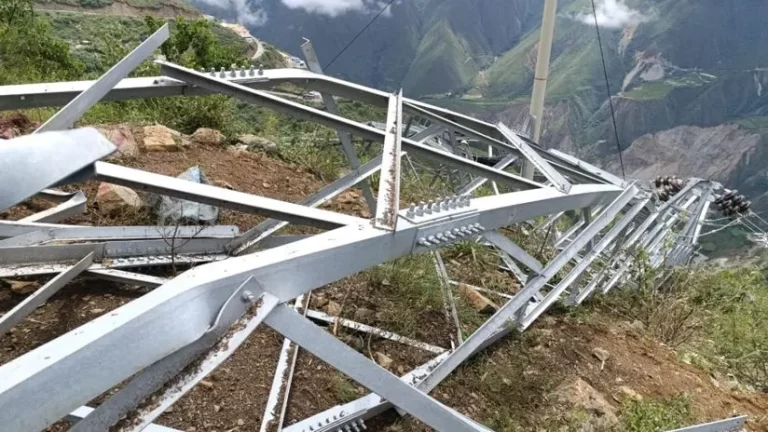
0, 27, 736, 432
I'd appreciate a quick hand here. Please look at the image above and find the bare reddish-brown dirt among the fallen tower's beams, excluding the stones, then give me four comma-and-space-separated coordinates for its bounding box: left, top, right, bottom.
0, 140, 768, 432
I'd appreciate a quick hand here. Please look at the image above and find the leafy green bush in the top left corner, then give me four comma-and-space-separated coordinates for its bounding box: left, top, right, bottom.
0, 0, 83, 85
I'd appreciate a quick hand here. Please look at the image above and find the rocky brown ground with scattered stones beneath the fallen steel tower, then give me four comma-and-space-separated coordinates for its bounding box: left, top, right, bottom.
0, 122, 768, 432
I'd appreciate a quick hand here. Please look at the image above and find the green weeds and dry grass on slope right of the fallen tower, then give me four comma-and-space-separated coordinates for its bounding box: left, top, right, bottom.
598, 253, 768, 387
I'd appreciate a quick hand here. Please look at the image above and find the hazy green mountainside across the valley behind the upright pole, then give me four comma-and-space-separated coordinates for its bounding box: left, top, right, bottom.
192, 0, 768, 215
